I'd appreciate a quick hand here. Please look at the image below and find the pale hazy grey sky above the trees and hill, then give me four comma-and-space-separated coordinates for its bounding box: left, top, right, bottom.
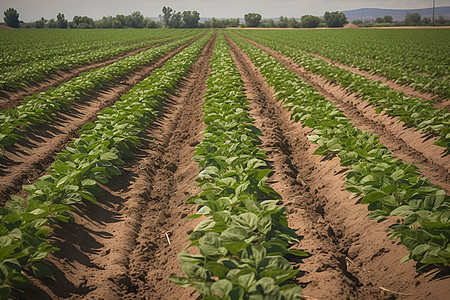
0, 0, 450, 22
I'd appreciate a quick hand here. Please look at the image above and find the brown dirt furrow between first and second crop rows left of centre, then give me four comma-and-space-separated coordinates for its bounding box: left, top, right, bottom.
0, 34, 204, 205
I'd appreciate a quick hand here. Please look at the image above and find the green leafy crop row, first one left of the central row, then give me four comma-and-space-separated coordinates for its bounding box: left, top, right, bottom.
0, 33, 212, 299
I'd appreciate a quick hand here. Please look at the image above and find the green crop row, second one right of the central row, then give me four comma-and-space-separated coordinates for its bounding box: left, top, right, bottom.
234, 31, 450, 152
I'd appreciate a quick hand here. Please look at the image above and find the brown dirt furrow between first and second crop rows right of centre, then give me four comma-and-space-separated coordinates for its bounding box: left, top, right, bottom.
237, 35, 450, 193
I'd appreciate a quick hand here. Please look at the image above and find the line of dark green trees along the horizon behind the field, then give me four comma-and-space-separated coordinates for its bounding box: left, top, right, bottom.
4, 6, 450, 29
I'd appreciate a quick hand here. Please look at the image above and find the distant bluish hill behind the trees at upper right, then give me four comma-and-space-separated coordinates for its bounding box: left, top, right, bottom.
342, 6, 450, 21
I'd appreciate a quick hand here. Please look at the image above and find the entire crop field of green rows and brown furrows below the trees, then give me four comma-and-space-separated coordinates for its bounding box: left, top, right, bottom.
0, 29, 450, 300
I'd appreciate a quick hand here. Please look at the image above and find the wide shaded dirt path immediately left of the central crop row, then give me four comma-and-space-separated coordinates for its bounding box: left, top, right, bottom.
14, 32, 215, 300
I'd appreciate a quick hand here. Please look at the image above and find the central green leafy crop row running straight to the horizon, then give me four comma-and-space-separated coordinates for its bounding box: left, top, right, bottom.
170, 35, 307, 300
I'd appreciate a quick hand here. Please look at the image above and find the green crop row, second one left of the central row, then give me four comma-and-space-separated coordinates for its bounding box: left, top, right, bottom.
0, 32, 207, 155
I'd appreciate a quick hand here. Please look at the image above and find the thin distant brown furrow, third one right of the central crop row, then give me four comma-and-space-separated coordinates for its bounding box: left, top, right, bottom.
308, 52, 450, 109
